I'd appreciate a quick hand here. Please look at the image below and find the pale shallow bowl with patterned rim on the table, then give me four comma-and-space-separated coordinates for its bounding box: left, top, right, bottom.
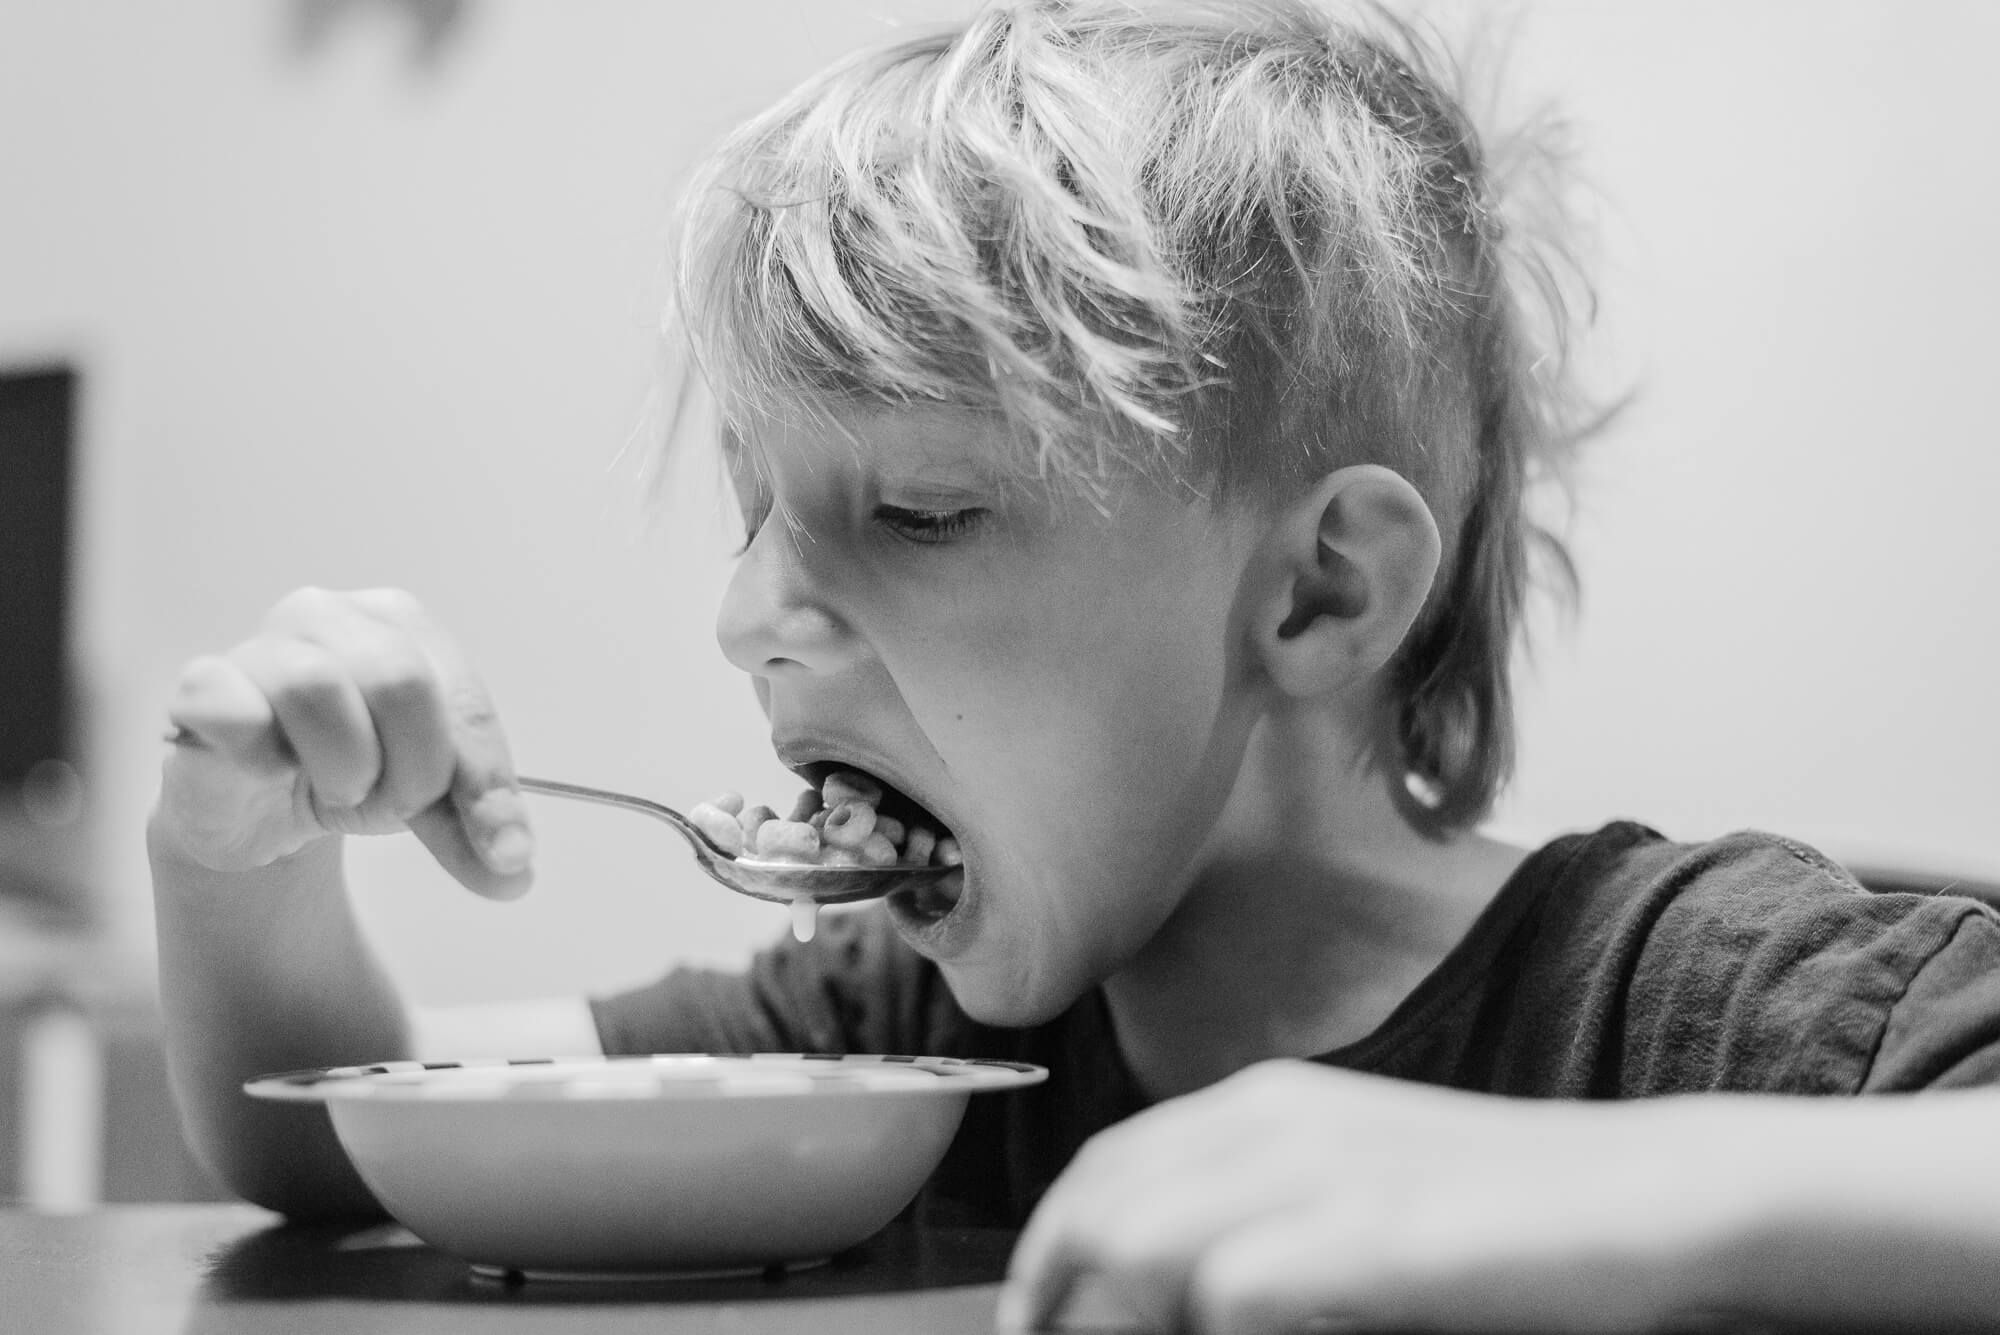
244, 1053, 1048, 1277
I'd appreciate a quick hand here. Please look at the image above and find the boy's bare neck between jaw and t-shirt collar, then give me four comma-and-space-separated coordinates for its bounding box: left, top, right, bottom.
1104, 719, 1526, 1099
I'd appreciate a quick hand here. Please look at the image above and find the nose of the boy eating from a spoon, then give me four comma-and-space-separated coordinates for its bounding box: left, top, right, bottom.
716, 524, 854, 677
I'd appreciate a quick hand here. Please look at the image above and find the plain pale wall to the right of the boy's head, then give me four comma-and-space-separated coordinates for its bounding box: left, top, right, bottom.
1506, 0, 2000, 871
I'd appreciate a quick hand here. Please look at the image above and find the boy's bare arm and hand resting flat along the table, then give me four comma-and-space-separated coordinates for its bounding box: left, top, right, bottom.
1000, 1061, 2000, 1335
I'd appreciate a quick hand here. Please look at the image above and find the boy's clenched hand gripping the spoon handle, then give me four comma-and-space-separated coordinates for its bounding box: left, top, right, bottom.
158, 590, 532, 899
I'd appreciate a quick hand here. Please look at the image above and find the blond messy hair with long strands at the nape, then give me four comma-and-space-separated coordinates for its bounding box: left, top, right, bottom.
676, 0, 1580, 829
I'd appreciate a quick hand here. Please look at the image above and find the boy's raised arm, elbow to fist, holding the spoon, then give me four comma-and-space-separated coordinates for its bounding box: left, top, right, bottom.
148, 590, 532, 1215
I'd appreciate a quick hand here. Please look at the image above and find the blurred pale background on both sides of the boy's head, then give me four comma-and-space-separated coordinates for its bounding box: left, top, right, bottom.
0, 0, 2000, 1209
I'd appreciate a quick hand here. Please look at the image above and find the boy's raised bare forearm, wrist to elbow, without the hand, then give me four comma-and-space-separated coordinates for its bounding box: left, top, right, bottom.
148, 819, 408, 1217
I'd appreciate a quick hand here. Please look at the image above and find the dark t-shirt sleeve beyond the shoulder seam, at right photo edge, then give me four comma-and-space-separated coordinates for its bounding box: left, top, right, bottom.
1862, 899, 2000, 1093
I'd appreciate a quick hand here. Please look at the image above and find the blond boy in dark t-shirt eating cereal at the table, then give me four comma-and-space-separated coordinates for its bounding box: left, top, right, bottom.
150, 0, 2000, 1331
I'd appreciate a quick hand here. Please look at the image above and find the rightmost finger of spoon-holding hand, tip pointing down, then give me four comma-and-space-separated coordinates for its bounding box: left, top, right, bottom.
354, 590, 534, 899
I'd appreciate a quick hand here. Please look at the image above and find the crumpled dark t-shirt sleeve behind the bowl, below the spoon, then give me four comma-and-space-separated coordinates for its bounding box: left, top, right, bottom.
590, 905, 956, 1055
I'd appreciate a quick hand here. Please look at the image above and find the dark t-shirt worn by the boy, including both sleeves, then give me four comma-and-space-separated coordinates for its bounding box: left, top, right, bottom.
592, 821, 2000, 1225
